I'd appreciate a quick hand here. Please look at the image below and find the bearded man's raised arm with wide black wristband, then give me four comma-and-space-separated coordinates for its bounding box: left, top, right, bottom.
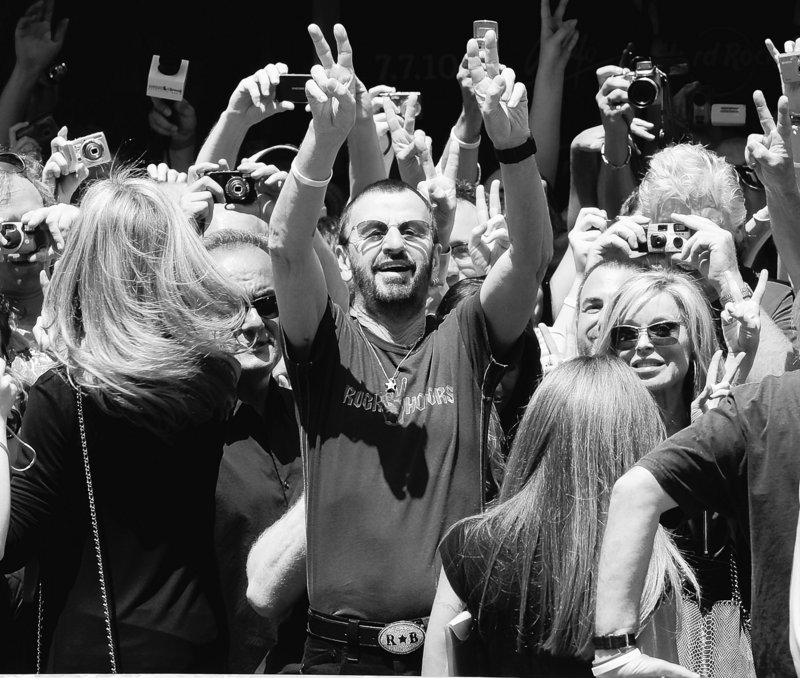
467, 31, 553, 356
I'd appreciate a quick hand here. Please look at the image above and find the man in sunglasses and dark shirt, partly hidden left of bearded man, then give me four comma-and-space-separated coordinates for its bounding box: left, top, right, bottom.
205, 229, 305, 673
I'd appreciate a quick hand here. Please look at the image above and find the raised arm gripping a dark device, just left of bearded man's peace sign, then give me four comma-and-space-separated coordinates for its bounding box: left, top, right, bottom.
195, 63, 294, 167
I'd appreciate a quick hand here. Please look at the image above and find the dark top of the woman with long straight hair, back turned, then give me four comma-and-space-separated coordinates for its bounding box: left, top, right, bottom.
439, 519, 592, 678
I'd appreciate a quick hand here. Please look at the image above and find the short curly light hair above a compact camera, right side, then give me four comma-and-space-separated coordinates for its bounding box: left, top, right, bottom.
637, 143, 747, 241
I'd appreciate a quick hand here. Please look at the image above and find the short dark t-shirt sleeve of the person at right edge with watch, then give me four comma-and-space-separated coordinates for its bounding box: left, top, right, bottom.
637, 384, 761, 519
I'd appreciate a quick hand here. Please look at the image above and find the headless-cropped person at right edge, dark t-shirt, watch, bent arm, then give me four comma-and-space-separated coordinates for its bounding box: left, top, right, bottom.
596, 372, 800, 678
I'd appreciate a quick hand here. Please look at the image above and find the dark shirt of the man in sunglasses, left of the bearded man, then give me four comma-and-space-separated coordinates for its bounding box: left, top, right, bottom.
215, 380, 307, 673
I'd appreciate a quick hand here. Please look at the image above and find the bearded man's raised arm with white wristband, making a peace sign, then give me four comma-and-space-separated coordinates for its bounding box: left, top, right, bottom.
269, 24, 356, 360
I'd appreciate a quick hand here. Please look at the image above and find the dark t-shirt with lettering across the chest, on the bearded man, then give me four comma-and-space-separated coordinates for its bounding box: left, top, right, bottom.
286, 295, 491, 621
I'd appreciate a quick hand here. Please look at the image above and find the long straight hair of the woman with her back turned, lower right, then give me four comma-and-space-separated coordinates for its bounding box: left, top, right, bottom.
463, 356, 694, 659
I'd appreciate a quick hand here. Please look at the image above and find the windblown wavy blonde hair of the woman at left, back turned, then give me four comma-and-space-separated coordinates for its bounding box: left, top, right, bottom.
43, 168, 247, 432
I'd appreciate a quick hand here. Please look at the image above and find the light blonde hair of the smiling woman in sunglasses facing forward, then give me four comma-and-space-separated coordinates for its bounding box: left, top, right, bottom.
595, 266, 719, 403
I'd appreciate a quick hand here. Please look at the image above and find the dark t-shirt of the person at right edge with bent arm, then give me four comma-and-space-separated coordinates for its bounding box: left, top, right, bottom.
638, 372, 800, 678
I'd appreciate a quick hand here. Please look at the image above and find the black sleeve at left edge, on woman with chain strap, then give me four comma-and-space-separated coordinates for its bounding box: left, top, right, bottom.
2, 372, 81, 572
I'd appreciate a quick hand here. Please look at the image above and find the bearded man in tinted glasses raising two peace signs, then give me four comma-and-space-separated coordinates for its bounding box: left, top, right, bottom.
270, 24, 552, 675
